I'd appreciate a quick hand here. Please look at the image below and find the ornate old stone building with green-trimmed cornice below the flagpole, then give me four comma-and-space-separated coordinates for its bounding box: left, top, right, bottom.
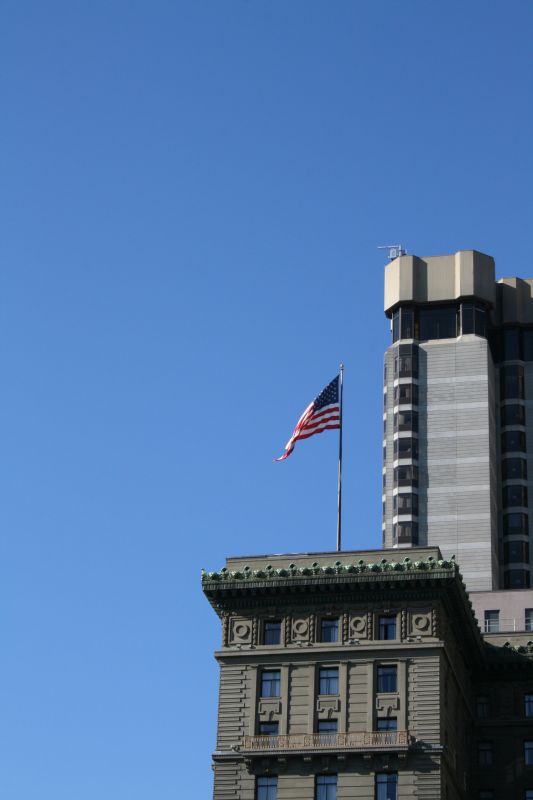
202, 548, 533, 800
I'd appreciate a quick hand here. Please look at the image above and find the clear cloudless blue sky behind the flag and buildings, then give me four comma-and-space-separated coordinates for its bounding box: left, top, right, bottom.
0, 0, 533, 800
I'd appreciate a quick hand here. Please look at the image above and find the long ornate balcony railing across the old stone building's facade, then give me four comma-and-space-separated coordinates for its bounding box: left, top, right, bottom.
242, 731, 410, 753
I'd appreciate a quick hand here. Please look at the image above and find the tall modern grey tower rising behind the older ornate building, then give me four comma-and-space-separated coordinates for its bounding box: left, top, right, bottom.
383, 250, 533, 591
